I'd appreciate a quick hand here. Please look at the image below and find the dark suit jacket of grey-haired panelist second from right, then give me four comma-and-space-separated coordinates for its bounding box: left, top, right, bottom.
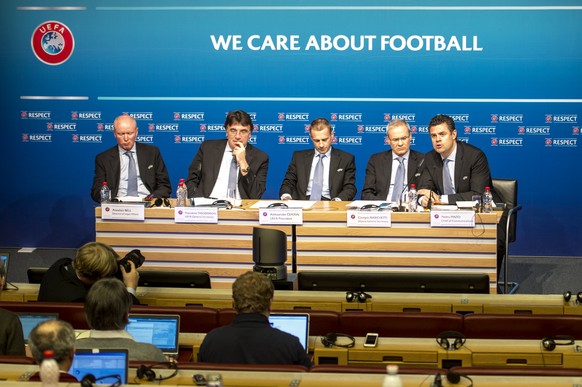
362, 150, 424, 200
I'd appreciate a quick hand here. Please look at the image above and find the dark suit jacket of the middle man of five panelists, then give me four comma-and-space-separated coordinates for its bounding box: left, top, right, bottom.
279, 148, 357, 200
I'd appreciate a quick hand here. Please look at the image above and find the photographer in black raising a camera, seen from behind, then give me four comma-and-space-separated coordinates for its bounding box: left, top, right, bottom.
38, 242, 144, 304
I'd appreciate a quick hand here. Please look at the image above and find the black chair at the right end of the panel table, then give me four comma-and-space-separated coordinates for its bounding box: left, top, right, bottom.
492, 178, 521, 294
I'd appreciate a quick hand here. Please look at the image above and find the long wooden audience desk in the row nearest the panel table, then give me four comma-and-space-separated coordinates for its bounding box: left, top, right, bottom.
0, 283, 582, 314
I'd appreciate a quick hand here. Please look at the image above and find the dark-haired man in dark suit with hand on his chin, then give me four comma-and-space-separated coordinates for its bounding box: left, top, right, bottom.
186, 110, 269, 199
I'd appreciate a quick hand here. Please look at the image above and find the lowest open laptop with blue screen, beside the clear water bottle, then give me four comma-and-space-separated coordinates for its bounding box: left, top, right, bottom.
69, 348, 129, 385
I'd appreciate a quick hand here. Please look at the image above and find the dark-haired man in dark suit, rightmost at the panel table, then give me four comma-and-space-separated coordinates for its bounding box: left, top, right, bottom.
418, 114, 492, 207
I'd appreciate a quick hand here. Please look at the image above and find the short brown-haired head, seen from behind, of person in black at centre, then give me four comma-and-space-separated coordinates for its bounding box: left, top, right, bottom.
232, 271, 275, 315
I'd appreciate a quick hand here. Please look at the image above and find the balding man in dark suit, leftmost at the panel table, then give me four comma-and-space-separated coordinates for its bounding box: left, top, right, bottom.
91, 114, 172, 202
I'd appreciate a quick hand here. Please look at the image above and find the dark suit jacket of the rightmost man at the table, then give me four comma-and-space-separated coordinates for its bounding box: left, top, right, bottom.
419, 141, 493, 204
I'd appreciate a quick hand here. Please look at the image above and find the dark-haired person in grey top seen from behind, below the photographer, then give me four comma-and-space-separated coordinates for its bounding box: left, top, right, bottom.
77, 278, 167, 362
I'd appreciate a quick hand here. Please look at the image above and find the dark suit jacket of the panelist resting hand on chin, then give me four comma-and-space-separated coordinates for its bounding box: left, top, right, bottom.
186, 139, 269, 199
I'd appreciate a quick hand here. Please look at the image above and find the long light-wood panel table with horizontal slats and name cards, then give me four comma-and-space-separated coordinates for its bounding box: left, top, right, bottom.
95, 200, 501, 293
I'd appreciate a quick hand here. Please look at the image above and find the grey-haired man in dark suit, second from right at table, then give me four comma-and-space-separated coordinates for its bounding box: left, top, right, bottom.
362, 120, 424, 201
